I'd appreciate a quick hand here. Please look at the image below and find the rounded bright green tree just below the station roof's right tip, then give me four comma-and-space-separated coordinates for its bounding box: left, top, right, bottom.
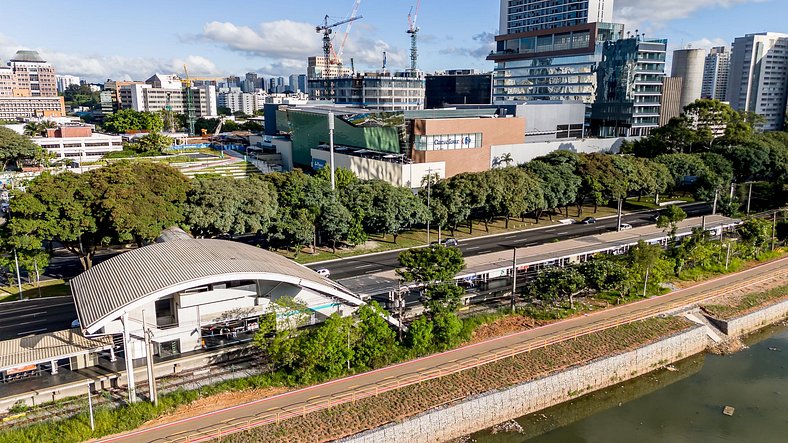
353, 301, 396, 368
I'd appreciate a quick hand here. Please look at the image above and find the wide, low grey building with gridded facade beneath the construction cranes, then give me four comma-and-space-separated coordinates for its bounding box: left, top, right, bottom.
309, 71, 425, 111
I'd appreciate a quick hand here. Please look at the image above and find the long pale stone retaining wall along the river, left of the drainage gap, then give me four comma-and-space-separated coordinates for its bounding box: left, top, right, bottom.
341, 326, 709, 443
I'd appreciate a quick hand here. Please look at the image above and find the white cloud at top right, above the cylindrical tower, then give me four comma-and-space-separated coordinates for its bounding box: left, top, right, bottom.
613, 0, 764, 32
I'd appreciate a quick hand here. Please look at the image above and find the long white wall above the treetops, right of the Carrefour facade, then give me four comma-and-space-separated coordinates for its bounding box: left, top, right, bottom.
490, 138, 637, 167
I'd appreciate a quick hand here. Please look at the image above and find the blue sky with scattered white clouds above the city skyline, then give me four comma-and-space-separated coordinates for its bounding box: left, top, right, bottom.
0, 0, 788, 82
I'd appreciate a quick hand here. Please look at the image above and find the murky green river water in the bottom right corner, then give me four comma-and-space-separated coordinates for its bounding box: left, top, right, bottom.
464, 324, 788, 443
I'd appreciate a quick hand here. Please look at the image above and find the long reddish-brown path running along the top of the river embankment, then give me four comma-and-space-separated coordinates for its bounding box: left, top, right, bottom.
99, 258, 788, 443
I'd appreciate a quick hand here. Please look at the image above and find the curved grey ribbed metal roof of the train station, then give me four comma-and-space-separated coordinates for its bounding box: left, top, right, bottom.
71, 239, 354, 328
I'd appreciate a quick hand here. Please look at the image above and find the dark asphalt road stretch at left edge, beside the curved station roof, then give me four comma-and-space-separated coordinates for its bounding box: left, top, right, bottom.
0, 297, 77, 340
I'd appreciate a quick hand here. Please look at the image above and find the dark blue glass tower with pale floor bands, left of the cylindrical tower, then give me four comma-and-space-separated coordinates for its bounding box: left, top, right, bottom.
591, 37, 668, 137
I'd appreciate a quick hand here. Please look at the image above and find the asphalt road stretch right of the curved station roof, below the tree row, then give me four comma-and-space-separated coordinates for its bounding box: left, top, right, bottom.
308, 203, 711, 280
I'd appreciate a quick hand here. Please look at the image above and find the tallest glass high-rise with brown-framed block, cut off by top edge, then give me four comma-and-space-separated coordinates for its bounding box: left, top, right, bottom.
487, 0, 624, 103
